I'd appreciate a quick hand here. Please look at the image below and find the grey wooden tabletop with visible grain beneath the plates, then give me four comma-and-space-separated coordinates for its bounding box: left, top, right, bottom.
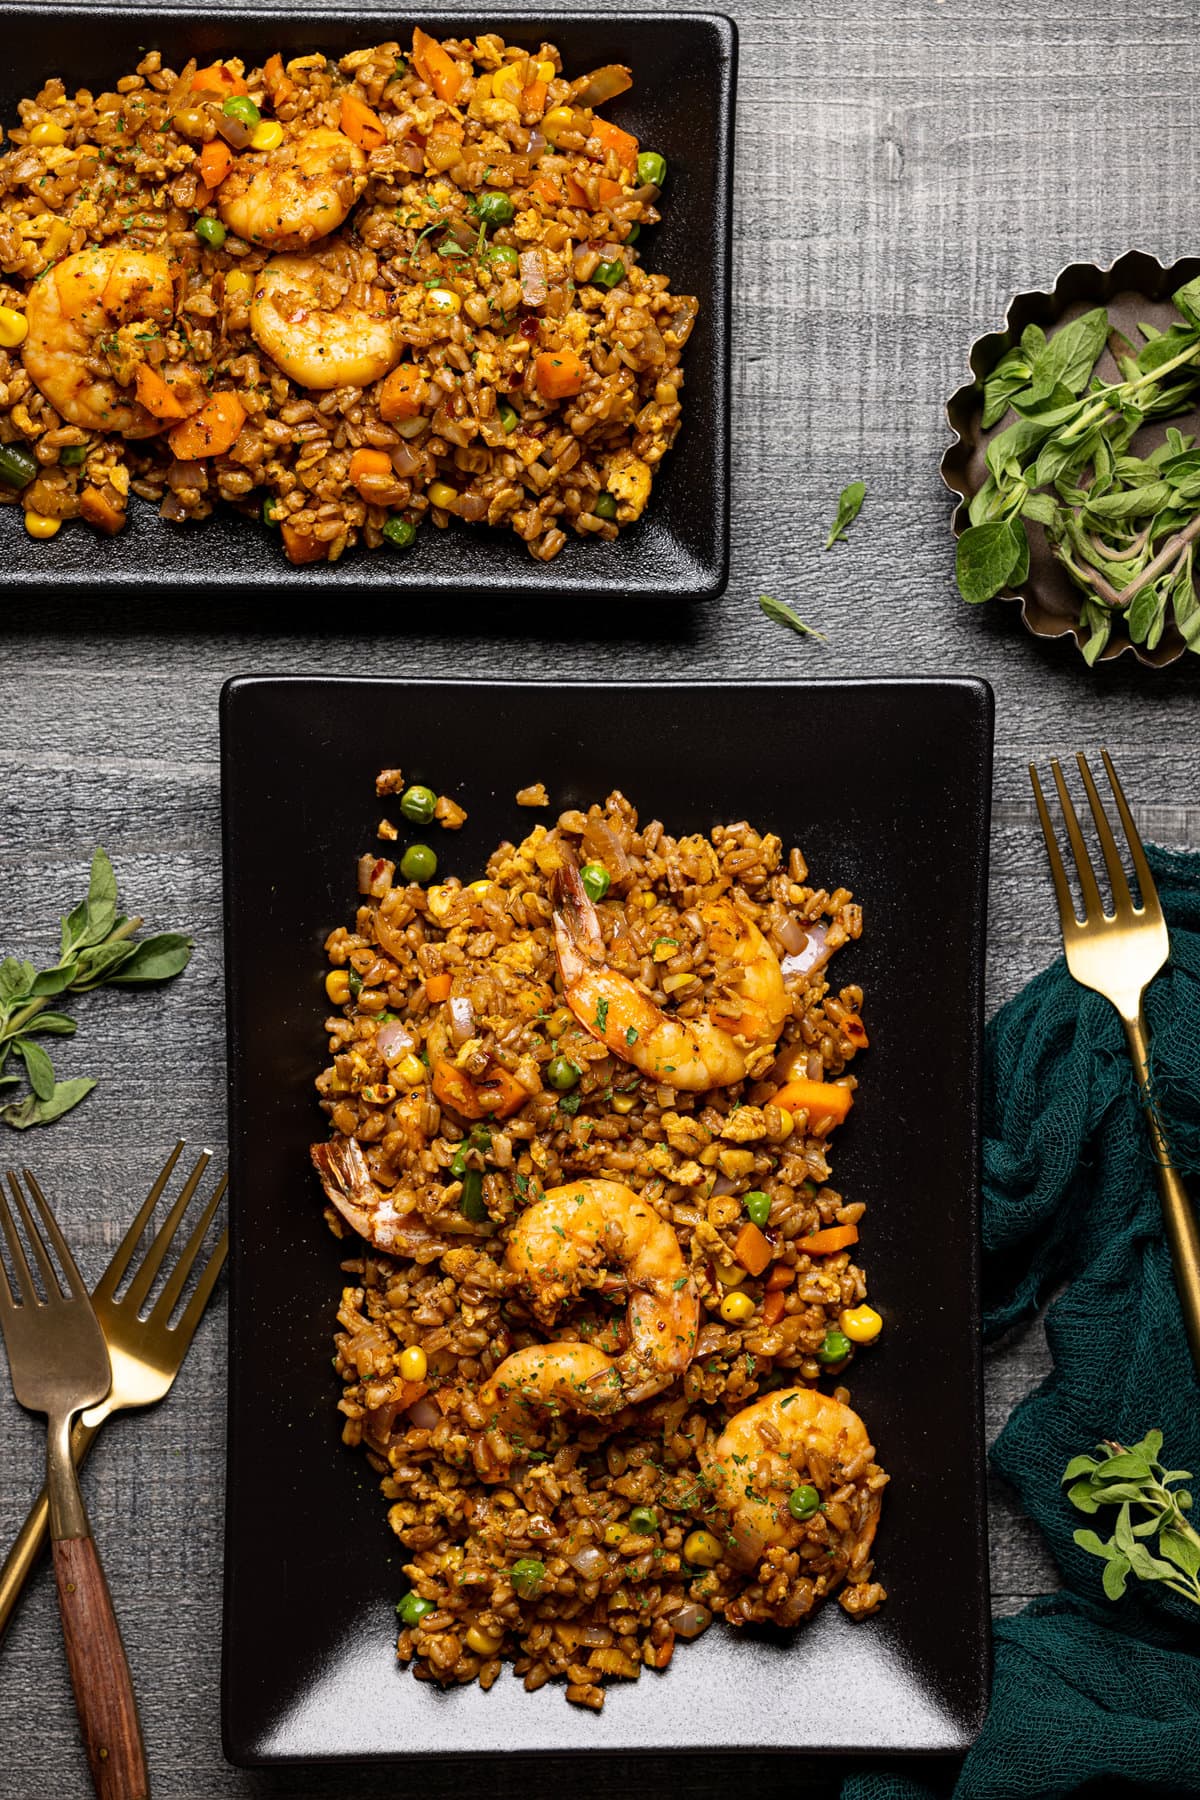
0, 0, 1200, 1800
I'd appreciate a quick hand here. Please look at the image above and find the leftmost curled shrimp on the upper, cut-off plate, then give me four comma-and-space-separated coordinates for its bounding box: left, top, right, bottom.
22, 245, 175, 437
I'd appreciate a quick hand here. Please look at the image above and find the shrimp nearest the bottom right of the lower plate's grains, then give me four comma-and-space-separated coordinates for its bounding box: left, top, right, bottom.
707, 1388, 882, 1566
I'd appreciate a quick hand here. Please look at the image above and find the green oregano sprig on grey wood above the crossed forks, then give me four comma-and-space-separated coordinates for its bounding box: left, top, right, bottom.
0, 850, 193, 1130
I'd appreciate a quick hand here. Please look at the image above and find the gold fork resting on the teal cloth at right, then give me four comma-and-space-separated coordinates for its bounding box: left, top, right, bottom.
1029, 751, 1200, 1373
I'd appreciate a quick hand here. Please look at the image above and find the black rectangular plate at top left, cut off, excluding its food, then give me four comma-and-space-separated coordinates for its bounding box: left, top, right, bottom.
0, 4, 738, 604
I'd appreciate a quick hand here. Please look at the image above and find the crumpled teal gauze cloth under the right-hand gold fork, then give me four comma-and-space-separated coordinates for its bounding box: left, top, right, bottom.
842, 850, 1200, 1800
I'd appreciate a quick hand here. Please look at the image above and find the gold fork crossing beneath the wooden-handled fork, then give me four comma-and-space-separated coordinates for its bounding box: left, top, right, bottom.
0, 1143, 228, 1636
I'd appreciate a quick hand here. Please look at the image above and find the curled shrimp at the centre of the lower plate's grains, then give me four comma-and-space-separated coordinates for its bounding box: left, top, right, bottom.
504, 1179, 700, 1411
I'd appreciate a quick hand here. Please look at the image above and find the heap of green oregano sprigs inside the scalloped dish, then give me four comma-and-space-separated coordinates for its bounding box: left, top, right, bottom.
955, 281, 1200, 662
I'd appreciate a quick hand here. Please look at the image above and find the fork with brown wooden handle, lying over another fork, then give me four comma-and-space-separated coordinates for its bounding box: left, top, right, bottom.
0, 1170, 149, 1800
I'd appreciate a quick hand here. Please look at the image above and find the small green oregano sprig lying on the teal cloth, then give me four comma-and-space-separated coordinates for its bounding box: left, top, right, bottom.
1063, 1431, 1200, 1606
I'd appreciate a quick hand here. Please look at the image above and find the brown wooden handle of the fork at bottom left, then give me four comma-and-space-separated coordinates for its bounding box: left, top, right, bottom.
54, 1537, 149, 1800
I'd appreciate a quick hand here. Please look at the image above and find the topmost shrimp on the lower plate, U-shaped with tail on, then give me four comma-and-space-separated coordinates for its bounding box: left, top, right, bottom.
554, 862, 790, 1091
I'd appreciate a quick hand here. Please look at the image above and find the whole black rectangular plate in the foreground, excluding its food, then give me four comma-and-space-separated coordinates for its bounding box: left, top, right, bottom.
221, 677, 991, 1764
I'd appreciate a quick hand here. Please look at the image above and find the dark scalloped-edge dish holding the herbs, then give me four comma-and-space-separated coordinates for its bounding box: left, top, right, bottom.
941, 250, 1200, 668
